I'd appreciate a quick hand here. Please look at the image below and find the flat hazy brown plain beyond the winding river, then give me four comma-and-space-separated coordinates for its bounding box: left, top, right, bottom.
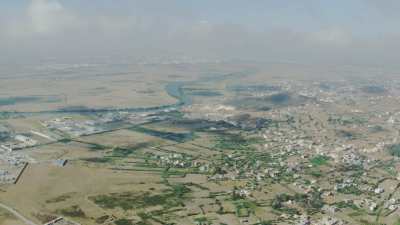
0, 64, 242, 111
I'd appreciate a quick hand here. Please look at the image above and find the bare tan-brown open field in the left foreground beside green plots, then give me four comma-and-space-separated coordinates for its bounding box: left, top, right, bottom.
0, 161, 164, 225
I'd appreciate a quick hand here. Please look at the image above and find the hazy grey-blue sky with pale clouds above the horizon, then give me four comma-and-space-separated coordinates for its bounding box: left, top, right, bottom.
0, 0, 400, 65
